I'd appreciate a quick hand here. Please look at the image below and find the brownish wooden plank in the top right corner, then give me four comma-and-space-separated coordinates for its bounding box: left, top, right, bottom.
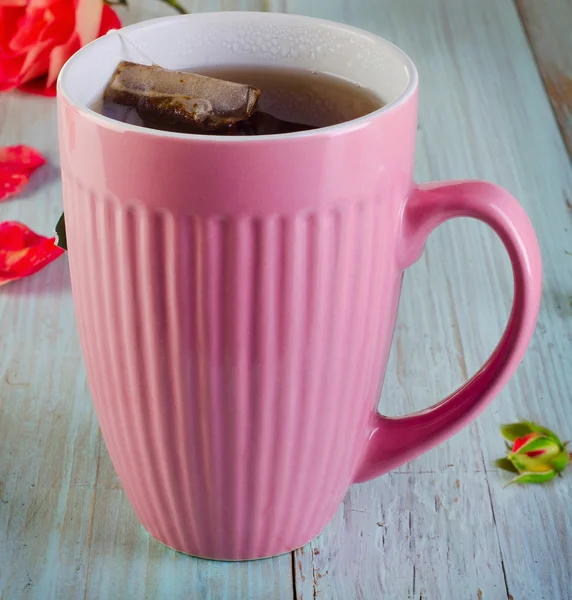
515, 0, 572, 157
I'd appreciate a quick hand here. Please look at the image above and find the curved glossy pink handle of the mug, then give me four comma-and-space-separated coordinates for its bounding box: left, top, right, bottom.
354, 181, 542, 483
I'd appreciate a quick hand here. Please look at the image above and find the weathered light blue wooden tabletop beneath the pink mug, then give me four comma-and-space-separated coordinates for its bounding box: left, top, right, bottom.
0, 0, 572, 600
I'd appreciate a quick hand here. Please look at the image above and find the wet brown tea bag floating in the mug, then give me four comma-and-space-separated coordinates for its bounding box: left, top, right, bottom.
103, 61, 260, 133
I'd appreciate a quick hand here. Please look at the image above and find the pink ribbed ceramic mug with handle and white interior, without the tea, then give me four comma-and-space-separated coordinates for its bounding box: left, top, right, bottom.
58, 13, 541, 560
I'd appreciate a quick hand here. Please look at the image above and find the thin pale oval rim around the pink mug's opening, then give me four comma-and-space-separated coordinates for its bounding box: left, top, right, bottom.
57, 11, 419, 144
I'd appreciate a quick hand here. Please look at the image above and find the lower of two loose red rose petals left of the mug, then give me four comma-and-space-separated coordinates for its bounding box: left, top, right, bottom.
0, 221, 65, 286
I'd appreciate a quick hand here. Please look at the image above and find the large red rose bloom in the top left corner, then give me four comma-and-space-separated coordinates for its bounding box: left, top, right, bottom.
0, 0, 121, 96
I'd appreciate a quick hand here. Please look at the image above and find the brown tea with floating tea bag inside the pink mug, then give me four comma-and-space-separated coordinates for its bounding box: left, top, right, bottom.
94, 61, 384, 136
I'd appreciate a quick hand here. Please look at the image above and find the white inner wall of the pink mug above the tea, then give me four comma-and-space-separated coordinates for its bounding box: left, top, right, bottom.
58, 12, 417, 124
